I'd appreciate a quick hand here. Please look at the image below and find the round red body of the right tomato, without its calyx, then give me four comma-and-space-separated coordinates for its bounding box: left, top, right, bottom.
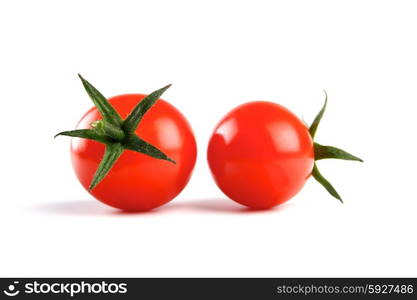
207, 101, 314, 209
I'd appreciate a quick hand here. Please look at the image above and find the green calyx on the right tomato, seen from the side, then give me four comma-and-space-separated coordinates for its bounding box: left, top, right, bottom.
309, 91, 363, 203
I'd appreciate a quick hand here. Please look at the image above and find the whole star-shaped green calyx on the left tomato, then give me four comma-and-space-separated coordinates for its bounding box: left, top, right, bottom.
55, 74, 175, 190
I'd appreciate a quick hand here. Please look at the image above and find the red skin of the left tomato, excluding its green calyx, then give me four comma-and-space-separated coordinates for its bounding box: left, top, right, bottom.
71, 94, 197, 211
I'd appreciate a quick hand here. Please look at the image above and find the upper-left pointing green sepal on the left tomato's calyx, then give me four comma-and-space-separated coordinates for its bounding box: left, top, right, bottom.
78, 74, 123, 126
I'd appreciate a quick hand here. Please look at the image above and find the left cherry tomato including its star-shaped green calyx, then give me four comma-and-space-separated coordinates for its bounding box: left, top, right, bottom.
58, 76, 197, 211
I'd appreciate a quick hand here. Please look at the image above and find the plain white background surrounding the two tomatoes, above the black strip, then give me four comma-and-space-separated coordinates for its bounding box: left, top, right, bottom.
0, 0, 417, 276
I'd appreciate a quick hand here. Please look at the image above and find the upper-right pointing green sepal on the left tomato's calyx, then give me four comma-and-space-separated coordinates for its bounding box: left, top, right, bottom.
123, 84, 171, 132
